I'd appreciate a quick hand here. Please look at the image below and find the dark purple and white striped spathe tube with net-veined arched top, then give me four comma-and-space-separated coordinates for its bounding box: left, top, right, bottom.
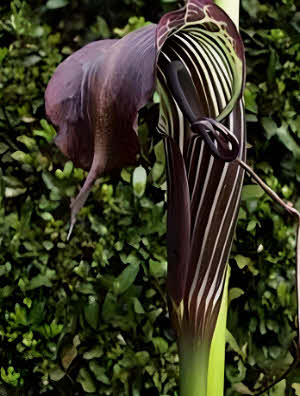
157, 0, 246, 341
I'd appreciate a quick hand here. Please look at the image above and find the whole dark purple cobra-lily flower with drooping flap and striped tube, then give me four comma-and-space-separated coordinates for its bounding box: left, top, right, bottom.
45, 0, 300, 394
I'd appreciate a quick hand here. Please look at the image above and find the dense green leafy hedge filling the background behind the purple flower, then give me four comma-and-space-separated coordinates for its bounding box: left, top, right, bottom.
0, 0, 300, 396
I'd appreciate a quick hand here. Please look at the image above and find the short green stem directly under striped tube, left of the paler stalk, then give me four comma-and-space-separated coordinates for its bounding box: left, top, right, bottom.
179, 339, 210, 396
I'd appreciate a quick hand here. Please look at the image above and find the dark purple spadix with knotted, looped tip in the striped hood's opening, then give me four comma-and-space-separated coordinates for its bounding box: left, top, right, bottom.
166, 61, 240, 162
